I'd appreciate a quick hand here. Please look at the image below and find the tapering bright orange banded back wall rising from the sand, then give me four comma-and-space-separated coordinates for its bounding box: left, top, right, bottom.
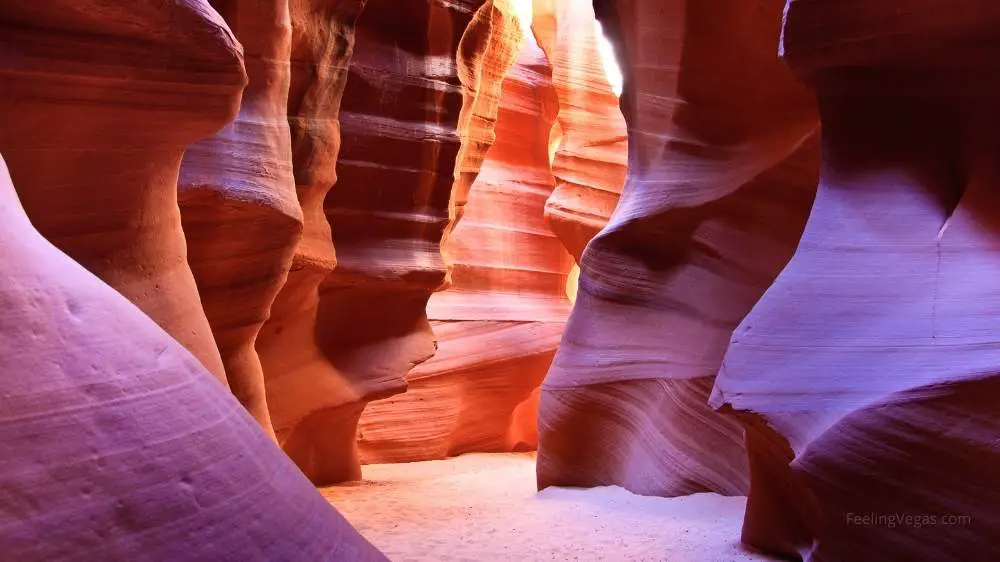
360, 39, 573, 462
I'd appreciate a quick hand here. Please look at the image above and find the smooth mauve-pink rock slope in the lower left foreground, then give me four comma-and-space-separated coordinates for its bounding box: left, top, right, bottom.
0, 152, 385, 562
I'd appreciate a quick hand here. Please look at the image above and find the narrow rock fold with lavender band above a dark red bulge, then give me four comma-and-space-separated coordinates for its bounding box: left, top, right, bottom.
178, 0, 302, 434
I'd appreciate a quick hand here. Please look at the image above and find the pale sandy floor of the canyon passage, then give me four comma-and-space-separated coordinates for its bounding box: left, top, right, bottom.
322, 454, 770, 562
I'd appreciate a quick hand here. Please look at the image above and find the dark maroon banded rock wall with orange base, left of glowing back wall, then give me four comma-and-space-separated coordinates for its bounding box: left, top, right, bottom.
258, 0, 518, 484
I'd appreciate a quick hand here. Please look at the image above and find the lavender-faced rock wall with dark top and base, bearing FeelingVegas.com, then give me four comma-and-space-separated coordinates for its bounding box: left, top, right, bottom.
712, 1, 1000, 562
